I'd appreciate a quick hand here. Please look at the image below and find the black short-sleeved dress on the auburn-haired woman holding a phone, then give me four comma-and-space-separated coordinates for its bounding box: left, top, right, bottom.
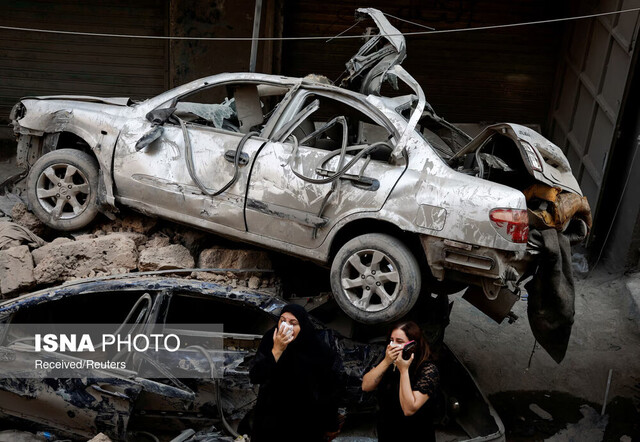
378, 361, 440, 442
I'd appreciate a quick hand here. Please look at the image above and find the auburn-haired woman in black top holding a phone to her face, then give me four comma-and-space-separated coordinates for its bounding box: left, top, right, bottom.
362, 321, 440, 442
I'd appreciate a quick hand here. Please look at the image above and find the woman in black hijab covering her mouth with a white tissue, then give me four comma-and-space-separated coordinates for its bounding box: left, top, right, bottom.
250, 304, 338, 442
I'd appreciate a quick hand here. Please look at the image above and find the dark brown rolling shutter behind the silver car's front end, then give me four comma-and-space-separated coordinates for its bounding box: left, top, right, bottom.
0, 0, 169, 130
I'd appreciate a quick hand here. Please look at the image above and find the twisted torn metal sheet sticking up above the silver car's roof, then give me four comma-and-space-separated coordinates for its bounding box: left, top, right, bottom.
341, 8, 407, 95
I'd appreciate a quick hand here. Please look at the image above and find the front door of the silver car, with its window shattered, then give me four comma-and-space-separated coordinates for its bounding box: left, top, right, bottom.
114, 83, 284, 233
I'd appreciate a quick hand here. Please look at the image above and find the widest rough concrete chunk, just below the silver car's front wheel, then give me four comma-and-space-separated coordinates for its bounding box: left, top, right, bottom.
33, 233, 138, 284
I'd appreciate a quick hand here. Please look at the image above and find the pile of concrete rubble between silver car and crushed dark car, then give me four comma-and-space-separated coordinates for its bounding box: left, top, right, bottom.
0, 193, 280, 298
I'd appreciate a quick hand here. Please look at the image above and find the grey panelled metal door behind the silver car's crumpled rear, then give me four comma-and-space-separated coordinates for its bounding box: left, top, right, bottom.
550, 0, 640, 220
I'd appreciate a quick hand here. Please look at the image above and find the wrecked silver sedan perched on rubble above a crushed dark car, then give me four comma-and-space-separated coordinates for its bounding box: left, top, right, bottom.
11, 9, 591, 334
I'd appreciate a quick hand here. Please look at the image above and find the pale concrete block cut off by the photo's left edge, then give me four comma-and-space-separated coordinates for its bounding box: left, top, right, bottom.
0, 246, 35, 296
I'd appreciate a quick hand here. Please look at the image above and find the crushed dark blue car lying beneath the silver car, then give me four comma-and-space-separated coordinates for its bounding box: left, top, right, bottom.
0, 274, 504, 441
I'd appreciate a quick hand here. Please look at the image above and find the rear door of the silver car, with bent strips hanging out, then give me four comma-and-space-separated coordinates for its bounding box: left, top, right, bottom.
245, 89, 406, 248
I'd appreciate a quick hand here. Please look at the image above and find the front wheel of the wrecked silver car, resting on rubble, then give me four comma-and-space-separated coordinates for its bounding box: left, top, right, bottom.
27, 149, 98, 230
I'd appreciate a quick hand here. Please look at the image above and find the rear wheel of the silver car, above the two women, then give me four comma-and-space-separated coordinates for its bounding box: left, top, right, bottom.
331, 233, 422, 324
